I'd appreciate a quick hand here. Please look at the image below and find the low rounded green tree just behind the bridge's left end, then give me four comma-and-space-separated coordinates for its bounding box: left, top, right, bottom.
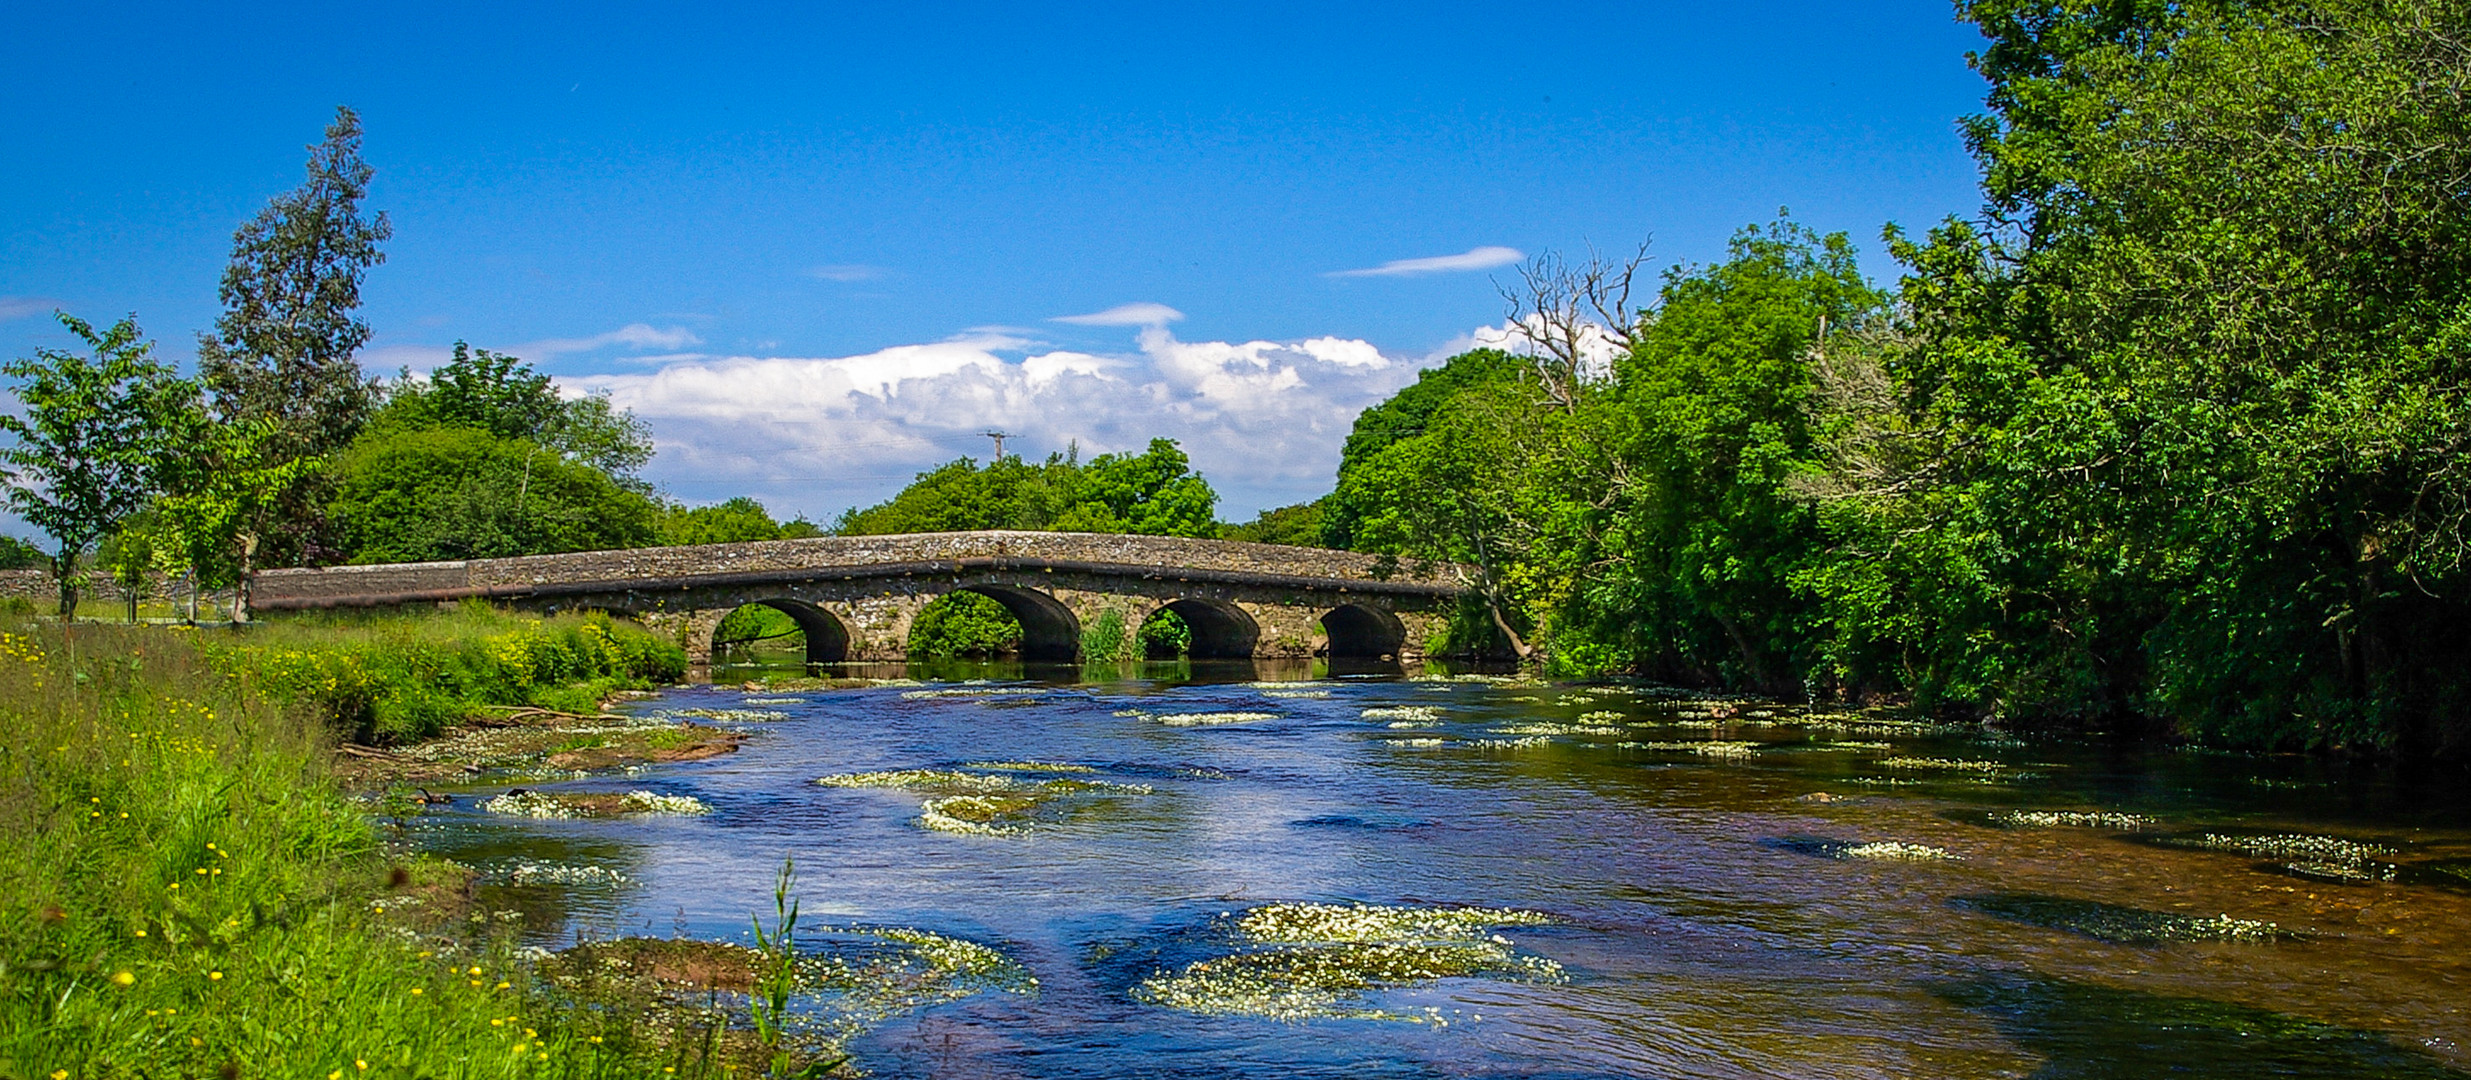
331, 428, 660, 563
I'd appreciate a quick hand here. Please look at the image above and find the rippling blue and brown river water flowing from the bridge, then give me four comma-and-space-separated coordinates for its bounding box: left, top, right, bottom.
415, 665, 2471, 1080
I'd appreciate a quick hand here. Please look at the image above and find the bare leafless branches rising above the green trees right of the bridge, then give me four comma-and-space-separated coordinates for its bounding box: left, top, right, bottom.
1495, 242, 1648, 408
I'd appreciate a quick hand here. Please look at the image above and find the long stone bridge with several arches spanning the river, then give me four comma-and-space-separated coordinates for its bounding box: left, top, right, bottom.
252, 531, 1460, 662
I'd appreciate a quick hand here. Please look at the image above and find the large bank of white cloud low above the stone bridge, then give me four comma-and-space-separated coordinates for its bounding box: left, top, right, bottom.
561, 321, 1421, 517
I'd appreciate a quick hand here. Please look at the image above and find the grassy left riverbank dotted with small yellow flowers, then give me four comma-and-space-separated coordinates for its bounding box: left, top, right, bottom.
0, 613, 780, 1080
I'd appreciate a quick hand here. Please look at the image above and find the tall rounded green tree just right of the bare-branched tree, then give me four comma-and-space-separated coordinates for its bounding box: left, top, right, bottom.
1559, 220, 1885, 694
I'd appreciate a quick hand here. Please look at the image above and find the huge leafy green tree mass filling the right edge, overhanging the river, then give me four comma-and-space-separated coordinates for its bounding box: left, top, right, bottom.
1811, 0, 2471, 746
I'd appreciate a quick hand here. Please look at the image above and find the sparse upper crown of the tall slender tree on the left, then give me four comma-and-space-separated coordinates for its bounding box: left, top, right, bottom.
198, 109, 393, 460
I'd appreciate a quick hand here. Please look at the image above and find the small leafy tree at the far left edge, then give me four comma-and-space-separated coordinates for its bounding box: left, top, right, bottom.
0, 314, 188, 620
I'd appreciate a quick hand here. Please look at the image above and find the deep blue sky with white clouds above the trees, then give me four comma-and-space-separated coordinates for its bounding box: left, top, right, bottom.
0, 0, 1982, 526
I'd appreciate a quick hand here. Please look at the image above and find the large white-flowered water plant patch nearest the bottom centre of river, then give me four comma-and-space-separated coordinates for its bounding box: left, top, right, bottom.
1129, 905, 1567, 1021
